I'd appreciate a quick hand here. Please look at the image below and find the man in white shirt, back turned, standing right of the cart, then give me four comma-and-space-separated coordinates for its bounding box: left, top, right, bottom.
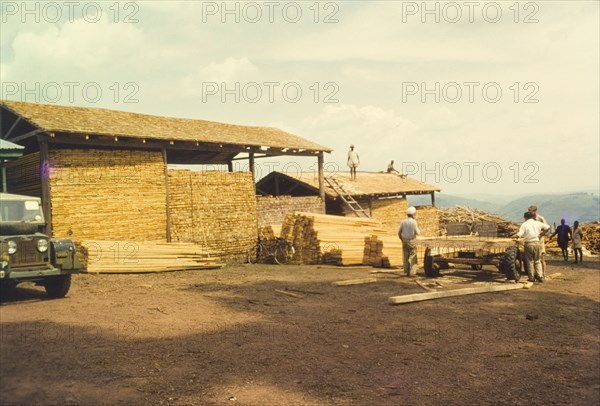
517, 211, 550, 282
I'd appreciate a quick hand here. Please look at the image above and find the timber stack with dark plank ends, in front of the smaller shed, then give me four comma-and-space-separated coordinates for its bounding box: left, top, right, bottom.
281, 212, 386, 265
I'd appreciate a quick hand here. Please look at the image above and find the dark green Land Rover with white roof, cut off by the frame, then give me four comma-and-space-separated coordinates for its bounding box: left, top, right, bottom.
0, 193, 82, 298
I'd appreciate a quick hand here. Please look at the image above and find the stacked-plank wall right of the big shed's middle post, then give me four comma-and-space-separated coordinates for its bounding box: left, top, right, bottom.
169, 170, 257, 261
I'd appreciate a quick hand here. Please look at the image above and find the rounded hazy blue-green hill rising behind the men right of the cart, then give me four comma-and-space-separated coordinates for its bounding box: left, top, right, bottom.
497, 193, 600, 224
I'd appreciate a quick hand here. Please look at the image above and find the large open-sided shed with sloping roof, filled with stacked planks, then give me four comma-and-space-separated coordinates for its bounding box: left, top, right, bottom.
0, 100, 331, 258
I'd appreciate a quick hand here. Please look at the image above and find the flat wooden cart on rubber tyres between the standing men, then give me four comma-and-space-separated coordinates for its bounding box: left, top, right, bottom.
417, 236, 521, 281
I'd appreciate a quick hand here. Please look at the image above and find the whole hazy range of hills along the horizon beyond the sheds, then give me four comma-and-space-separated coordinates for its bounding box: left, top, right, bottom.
408, 192, 600, 225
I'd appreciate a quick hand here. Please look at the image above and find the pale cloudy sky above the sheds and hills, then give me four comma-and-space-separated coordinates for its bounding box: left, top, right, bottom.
0, 0, 600, 195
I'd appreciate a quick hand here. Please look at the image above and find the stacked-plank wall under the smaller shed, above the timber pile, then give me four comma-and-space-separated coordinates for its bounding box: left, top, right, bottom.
256, 196, 325, 227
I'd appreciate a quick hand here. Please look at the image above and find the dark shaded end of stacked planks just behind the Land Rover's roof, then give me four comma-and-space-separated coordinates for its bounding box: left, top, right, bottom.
5, 152, 42, 197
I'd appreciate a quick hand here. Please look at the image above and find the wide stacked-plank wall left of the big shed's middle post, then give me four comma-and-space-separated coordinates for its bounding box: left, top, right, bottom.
49, 149, 167, 241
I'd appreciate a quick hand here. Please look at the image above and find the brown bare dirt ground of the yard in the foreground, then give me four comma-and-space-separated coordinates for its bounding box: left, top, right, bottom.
0, 260, 600, 405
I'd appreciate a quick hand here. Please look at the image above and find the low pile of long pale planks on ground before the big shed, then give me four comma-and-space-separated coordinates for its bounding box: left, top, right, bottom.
78, 240, 223, 273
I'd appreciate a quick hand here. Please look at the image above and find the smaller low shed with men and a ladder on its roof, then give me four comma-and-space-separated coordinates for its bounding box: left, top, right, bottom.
256, 172, 441, 237
